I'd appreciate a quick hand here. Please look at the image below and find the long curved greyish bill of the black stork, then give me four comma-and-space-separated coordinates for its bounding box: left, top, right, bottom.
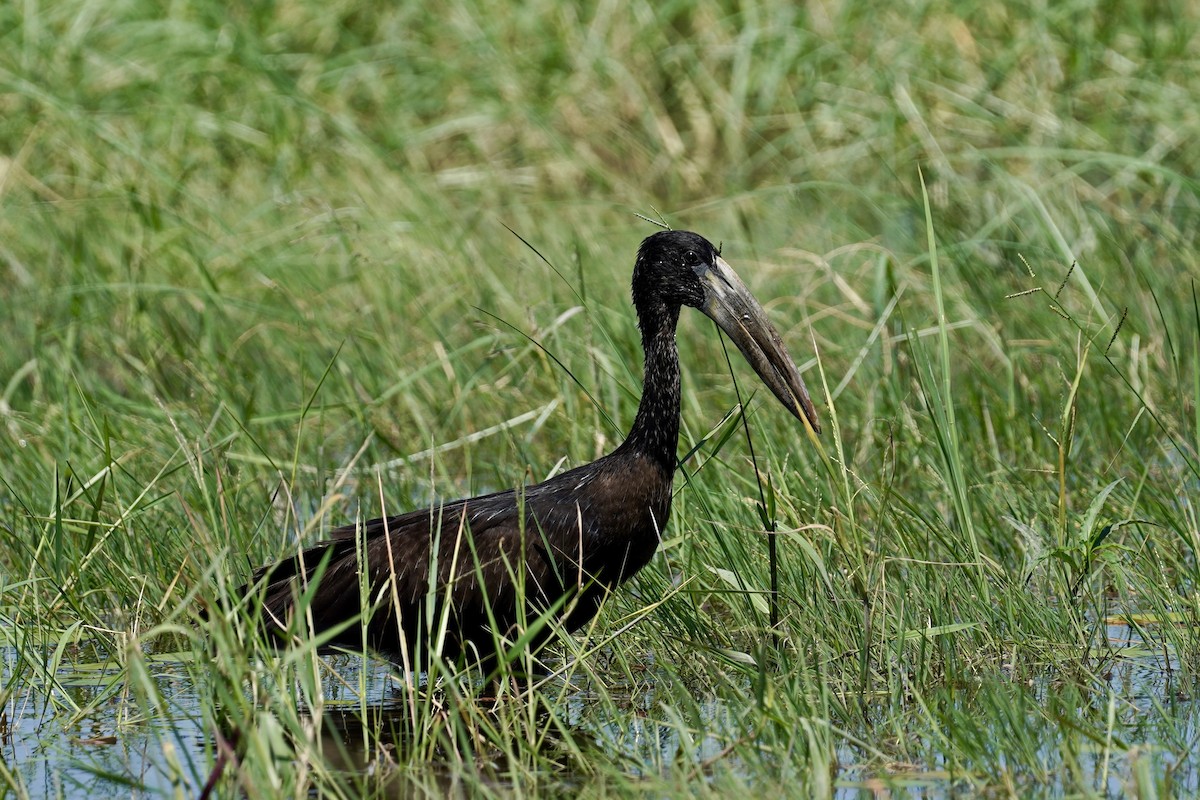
700, 257, 821, 433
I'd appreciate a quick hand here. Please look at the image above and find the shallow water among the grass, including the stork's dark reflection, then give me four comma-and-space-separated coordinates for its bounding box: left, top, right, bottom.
0, 621, 1200, 799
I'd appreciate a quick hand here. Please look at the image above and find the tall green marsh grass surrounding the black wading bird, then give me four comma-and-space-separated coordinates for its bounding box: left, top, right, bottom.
0, 0, 1200, 796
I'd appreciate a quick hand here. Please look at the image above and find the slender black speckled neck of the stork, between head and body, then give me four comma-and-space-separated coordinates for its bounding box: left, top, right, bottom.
622, 303, 679, 475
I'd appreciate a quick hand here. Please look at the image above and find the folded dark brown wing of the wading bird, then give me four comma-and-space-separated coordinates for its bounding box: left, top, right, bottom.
247, 491, 576, 655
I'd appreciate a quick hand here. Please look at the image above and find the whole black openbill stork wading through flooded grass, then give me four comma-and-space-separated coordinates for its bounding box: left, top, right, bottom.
241, 230, 820, 669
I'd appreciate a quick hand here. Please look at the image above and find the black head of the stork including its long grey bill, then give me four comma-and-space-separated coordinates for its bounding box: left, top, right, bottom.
634, 230, 821, 433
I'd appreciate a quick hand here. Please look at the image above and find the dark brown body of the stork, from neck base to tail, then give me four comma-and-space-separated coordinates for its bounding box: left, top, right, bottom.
241, 464, 670, 657
